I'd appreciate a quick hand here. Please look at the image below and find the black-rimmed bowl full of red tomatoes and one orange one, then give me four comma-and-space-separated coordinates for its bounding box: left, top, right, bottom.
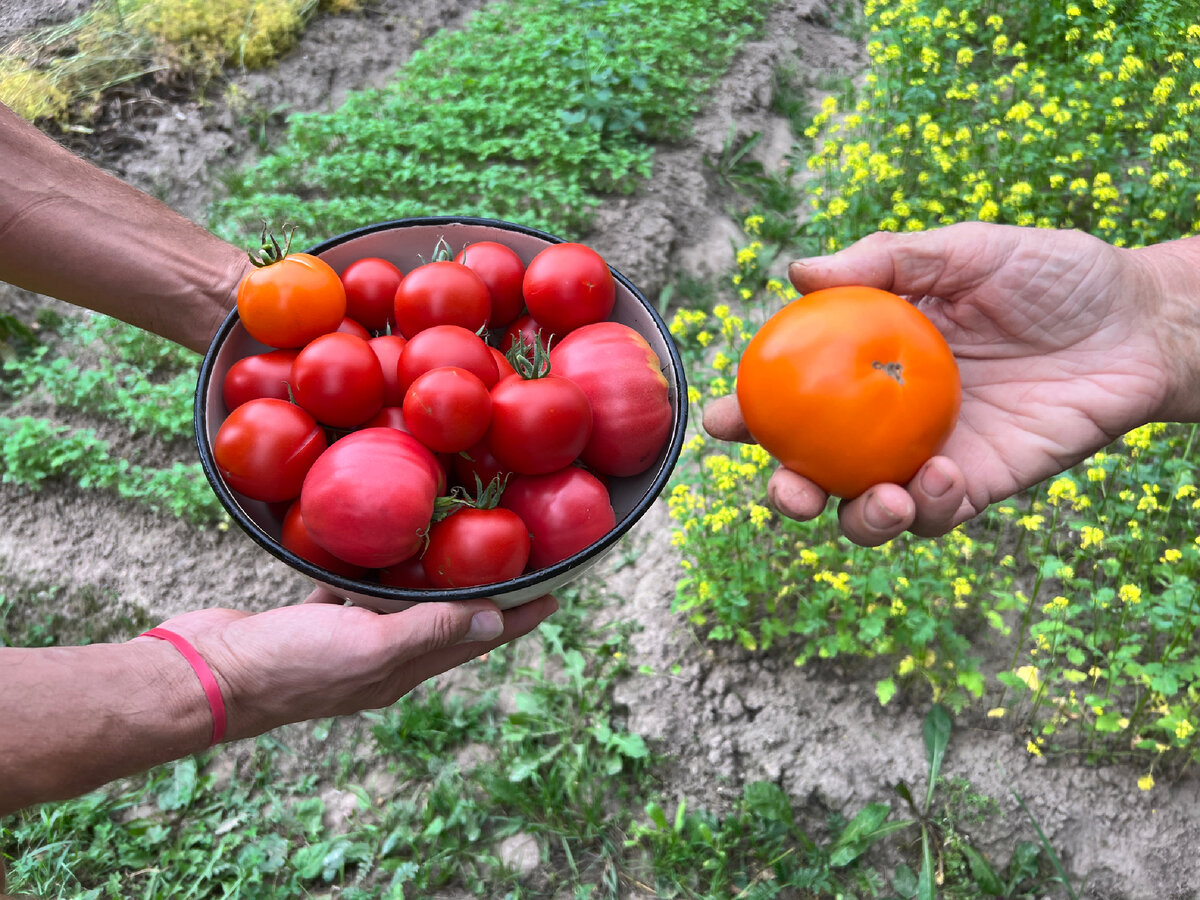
196, 216, 688, 612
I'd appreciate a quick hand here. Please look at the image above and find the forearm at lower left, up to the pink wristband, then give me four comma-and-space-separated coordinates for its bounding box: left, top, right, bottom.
0, 641, 212, 817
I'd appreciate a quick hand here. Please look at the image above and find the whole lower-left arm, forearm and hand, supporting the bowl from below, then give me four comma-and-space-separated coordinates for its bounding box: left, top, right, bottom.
0, 592, 557, 817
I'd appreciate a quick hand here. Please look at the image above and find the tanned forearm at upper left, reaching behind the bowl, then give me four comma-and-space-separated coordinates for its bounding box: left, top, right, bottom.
0, 104, 251, 350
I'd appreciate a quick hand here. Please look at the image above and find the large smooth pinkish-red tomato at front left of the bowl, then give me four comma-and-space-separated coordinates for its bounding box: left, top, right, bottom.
300, 428, 439, 569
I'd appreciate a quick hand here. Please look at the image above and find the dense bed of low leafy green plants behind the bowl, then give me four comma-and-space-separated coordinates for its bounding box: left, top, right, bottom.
214, 0, 766, 242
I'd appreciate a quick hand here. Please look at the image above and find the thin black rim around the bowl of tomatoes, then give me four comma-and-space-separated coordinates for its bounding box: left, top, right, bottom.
193, 216, 688, 602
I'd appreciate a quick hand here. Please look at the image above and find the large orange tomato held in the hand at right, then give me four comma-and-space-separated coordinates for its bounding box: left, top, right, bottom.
737, 287, 962, 498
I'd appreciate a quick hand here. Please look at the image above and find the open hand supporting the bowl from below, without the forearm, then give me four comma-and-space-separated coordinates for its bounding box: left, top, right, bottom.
146, 589, 558, 740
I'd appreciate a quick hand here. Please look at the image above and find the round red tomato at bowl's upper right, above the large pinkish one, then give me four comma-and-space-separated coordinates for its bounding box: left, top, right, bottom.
522, 244, 617, 337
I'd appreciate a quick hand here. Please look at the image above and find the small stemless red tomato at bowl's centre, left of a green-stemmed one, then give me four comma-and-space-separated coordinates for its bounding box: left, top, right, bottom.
403, 366, 492, 454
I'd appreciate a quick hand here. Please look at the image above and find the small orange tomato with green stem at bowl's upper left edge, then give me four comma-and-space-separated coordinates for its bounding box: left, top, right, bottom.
238, 236, 346, 349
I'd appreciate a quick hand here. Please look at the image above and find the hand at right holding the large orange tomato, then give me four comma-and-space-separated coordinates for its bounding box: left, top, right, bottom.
704, 223, 1170, 546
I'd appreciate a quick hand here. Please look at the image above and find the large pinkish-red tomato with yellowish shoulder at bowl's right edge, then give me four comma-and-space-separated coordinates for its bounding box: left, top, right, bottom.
550, 322, 674, 476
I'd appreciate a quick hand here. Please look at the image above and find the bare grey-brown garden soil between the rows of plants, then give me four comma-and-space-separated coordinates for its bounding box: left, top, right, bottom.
0, 0, 1200, 900
